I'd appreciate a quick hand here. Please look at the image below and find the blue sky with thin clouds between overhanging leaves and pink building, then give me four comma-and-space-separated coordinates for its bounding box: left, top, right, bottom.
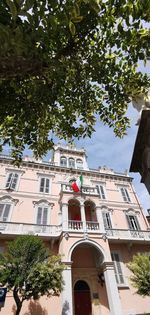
73, 105, 150, 214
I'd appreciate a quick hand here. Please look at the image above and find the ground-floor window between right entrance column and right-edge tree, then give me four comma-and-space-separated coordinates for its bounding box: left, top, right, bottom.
111, 252, 124, 284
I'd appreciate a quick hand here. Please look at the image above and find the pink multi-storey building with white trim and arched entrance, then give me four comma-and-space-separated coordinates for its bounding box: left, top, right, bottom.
0, 145, 150, 315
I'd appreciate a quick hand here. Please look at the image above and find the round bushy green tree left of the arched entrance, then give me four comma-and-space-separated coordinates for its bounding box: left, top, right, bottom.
0, 235, 64, 315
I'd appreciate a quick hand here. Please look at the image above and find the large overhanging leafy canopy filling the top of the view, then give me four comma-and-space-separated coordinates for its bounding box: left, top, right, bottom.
0, 0, 150, 160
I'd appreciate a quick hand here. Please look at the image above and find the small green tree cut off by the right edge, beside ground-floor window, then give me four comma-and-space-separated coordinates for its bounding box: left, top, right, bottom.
128, 253, 150, 296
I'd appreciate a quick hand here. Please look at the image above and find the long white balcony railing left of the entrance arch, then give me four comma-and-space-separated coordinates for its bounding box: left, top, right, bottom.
0, 221, 62, 237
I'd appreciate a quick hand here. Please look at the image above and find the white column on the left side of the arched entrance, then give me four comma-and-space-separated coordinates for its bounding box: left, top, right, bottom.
61, 263, 73, 315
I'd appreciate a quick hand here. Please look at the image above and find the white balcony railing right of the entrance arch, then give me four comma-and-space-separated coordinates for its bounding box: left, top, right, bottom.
106, 229, 150, 241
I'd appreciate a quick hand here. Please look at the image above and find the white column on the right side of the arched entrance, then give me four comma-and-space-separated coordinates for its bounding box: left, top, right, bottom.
103, 262, 123, 315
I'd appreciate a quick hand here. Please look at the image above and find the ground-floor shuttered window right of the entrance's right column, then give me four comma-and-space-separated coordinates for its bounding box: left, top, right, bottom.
111, 251, 127, 286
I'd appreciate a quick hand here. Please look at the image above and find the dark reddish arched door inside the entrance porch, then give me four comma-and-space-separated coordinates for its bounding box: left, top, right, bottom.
74, 280, 92, 315
